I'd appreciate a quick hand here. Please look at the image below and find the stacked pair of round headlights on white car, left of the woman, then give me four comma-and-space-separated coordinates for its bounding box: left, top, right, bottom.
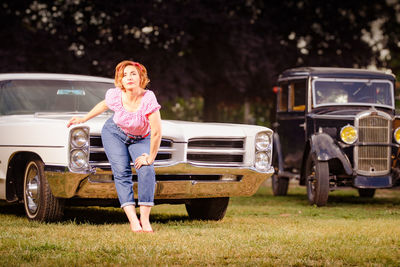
69, 127, 89, 172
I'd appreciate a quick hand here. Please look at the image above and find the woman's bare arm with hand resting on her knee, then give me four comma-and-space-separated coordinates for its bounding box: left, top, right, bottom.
135, 110, 162, 169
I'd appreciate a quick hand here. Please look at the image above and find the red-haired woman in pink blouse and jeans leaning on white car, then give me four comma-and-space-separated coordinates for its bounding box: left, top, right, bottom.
67, 61, 161, 232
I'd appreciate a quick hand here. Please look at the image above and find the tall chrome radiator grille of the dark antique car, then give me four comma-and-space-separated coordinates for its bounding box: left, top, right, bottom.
354, 112, 391, 176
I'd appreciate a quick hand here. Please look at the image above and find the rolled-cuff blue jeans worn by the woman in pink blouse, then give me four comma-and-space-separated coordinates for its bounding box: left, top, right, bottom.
101, 117, 156, 208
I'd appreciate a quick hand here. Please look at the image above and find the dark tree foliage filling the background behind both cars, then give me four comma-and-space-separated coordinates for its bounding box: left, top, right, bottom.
0, 0, 400, 121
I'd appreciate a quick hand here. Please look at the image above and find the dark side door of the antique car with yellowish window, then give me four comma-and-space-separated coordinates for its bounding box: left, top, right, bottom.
275, 79, 307, 173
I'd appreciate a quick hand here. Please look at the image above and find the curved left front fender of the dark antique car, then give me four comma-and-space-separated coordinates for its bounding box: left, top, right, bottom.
310, 133, 353, 175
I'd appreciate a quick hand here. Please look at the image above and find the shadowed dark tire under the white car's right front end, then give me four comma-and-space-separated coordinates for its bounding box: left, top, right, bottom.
186, 197, 229, 221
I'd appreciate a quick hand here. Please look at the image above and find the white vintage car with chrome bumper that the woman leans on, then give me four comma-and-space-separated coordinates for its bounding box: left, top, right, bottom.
0, 73, 273, 221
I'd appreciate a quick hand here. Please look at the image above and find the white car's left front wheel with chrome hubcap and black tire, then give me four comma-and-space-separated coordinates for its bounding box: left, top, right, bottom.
23, 158, 64, 221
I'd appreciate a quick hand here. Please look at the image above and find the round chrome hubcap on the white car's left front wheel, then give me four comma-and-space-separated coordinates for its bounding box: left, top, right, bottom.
25, 164, 40, 214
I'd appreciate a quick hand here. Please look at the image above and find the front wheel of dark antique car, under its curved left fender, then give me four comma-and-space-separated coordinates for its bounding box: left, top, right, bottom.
306, 154, 329, 207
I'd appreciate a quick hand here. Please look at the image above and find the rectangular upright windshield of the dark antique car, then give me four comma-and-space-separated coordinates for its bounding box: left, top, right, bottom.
312, 78, 394, 108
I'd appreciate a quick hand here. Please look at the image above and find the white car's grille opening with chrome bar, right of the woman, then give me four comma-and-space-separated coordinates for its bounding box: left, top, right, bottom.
187, 138, 245, 166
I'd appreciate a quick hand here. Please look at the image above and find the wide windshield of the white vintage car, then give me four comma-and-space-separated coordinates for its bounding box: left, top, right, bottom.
0, 80, 114, 115
